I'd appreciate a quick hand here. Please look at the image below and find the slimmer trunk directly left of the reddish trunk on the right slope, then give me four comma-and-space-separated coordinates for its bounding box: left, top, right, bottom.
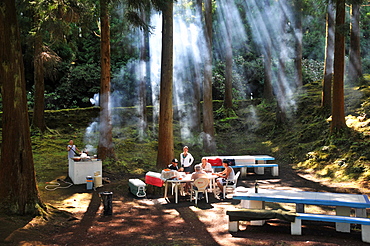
321, 1, 335, 109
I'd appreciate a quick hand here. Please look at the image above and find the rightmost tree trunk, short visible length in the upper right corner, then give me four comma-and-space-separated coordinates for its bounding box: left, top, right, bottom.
347, 3, 362, 83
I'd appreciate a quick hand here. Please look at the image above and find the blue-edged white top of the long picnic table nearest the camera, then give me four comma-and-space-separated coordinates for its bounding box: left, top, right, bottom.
233, 189, 370, 208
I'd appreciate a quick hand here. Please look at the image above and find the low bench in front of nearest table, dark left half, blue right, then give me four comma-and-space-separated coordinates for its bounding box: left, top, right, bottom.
226, 209, 370, 243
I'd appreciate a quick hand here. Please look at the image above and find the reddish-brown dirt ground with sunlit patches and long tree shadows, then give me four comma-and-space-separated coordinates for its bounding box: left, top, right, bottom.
0, 163, 368, 246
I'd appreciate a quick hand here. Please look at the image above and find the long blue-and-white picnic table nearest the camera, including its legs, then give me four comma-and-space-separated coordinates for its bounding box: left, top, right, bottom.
233, 189, 370, 232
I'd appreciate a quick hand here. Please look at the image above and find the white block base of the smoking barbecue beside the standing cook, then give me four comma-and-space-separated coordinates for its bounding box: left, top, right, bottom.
68, 158, 103, 184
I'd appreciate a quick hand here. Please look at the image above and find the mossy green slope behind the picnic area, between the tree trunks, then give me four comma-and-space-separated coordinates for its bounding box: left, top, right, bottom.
32, 78, 370, 189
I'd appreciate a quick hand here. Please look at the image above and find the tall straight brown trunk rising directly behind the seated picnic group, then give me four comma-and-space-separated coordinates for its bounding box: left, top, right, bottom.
157, 1, 174, 168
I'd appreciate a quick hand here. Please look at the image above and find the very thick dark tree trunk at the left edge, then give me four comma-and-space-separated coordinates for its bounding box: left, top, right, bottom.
0, 0, 43, 215
